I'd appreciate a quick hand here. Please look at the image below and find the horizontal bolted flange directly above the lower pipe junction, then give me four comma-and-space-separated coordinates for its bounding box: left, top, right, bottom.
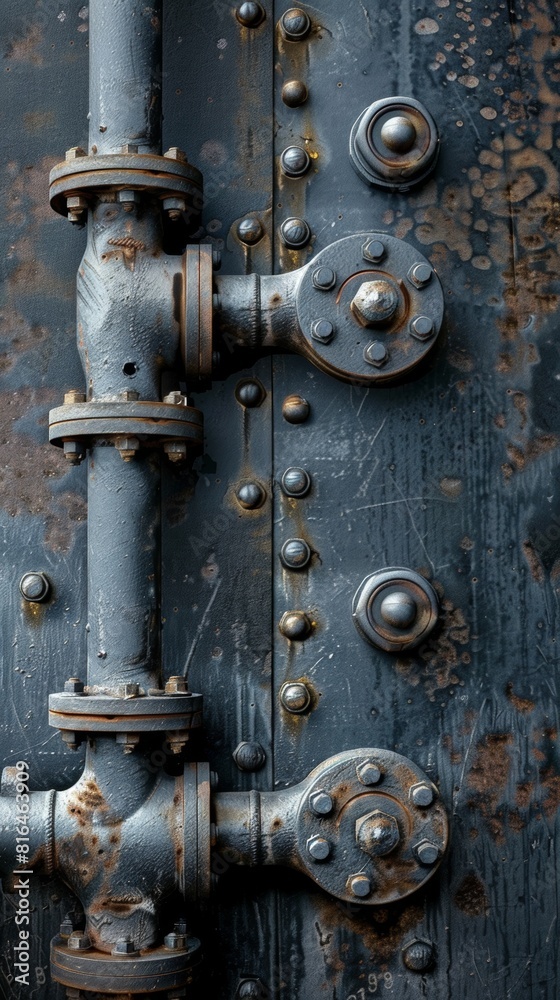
49, 691, 202, 733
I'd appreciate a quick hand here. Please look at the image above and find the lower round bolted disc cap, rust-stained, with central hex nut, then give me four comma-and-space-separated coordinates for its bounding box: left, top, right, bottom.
296, 749, 449, 906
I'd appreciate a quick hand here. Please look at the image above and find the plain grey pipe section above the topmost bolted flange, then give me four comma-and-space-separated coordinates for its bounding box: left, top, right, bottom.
89, 0, 162, 153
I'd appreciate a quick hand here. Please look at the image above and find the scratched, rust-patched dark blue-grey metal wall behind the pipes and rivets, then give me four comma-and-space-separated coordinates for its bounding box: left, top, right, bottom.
0, 0, 560, 1000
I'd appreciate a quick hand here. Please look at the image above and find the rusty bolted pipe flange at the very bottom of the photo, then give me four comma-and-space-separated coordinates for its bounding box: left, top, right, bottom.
51, 935, 202, 994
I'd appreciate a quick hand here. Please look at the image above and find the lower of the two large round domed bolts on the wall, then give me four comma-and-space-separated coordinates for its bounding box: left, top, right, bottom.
352, 568, 439, 653
